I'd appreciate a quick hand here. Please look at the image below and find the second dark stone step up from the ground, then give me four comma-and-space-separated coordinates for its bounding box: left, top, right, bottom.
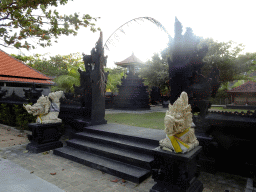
66, 139, 154, 170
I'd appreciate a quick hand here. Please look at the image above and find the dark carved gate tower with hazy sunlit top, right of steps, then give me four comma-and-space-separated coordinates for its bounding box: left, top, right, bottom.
168, 18, 220, 118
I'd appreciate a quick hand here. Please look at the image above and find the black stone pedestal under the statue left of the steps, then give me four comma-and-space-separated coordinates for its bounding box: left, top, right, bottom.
26, 123, 63, 153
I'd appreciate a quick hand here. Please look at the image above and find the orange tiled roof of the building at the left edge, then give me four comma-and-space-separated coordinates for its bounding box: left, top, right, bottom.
0, 49, 54, 85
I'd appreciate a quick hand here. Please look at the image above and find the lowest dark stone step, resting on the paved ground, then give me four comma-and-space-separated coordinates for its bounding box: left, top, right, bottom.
53, 146, 151, 183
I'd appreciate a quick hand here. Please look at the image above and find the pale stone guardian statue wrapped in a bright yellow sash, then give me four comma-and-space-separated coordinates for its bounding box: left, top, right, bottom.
159, 92, 199, 153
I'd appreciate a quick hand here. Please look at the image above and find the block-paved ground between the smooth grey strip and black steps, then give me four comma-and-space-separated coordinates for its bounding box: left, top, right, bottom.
0, 144, 246, 192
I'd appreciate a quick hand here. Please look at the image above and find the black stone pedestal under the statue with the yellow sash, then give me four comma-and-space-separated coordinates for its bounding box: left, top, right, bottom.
150, 146, 203, 192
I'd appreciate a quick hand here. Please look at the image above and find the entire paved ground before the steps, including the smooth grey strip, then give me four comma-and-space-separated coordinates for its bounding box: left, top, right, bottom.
0, 108, 247, 192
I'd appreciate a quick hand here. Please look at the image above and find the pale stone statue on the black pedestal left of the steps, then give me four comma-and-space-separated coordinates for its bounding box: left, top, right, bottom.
23, 91, 64, 124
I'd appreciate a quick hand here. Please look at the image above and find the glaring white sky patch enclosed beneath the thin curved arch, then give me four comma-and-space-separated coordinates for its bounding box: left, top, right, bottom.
105, 21, 169, 68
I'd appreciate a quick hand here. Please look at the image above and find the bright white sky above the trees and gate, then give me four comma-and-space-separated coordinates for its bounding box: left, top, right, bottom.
1, 0, 256, 68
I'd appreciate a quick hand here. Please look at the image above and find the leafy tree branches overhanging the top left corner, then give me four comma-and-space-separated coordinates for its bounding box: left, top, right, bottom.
0, 0, 100, 50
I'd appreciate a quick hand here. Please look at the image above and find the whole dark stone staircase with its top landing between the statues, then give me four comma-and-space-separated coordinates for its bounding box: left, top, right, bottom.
53, 124, 165, 183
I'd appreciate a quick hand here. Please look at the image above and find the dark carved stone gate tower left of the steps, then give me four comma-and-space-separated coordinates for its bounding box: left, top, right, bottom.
59, 33, 108, 132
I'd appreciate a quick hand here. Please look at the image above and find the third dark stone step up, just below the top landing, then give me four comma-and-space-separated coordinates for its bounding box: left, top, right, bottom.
73, 132, 158, 155
